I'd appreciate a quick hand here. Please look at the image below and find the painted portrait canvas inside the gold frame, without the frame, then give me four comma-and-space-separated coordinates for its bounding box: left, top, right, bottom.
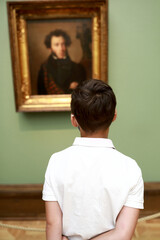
27, 19, 92, 95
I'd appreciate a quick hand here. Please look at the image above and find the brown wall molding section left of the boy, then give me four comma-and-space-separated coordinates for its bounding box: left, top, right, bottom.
0, 184, 45, 220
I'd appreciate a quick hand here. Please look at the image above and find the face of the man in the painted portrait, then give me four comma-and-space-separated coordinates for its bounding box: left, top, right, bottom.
51, 36, 66, 59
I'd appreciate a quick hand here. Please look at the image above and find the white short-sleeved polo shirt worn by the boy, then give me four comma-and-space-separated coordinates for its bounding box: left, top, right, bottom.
43, 138, 143, 240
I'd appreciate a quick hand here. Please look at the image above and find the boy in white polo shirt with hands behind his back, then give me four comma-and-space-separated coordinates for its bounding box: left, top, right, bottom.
43, 79, 143, 240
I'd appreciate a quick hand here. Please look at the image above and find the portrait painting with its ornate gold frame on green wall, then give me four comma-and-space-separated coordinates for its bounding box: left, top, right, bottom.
7, 0, 108, 112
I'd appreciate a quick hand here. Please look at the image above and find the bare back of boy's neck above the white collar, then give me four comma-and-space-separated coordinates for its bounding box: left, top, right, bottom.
80, 128, 109, 138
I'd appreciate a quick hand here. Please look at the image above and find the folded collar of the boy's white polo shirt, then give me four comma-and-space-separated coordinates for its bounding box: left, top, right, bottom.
73, 137, 115, 149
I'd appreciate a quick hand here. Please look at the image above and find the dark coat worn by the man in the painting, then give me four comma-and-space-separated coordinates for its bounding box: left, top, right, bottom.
37, 54, 86, 94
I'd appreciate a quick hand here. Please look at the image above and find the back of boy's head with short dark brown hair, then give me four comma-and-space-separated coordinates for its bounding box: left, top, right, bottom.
71, 79, 116, 132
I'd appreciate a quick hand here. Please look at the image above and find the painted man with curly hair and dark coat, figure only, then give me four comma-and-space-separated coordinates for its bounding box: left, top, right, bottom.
37, 29, 86, 94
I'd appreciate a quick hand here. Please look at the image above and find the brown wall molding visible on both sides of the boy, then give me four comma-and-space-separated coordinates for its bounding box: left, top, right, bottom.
0, 182, 160, 220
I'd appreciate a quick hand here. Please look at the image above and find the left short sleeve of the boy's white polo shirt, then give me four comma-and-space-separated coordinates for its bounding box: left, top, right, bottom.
42, 160, 57, 201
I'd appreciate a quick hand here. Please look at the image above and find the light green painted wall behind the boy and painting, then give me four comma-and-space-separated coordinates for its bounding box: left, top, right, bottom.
0, 0, 160, 184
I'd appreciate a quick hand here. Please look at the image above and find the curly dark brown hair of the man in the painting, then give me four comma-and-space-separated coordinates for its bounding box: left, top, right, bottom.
44, 29, 71, 48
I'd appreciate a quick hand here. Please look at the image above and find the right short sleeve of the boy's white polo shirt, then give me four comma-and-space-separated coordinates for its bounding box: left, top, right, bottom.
124, 172, 144, 209
